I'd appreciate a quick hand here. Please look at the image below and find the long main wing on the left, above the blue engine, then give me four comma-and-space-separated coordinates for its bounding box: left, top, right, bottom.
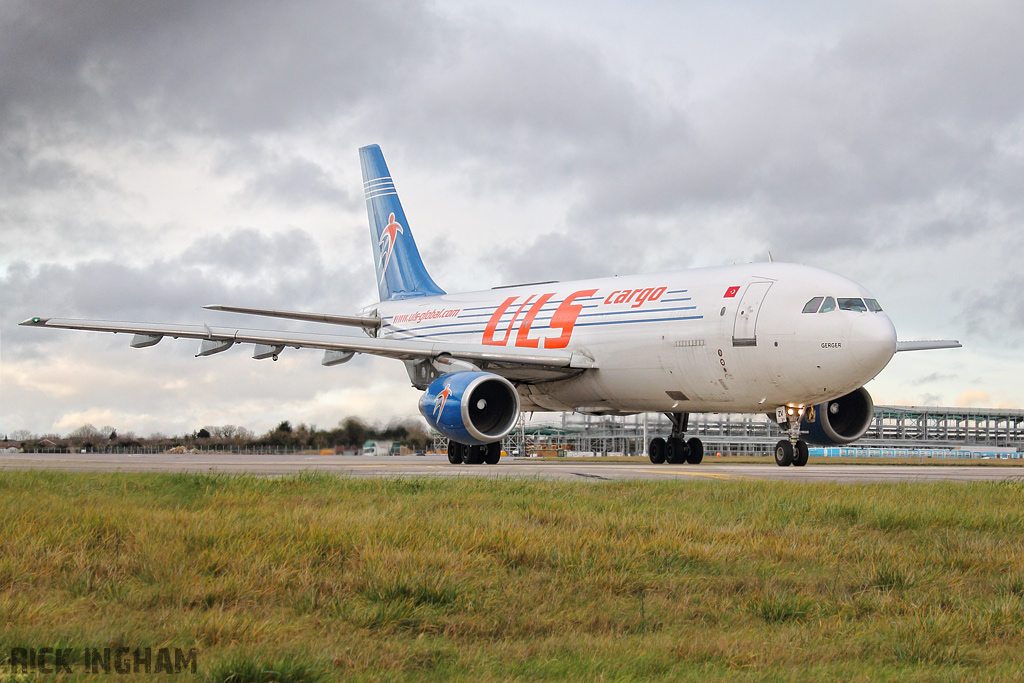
20, 317, 596, 380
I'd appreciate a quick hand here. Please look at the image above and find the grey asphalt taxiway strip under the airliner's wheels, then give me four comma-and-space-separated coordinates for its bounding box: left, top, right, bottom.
0, 454, 1024, 482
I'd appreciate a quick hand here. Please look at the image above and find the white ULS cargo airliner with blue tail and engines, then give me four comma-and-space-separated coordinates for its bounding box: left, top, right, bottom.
22, 144, 961, 466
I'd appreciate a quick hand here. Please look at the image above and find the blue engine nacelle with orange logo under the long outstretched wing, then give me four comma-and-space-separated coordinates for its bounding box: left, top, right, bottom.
420, 372, 519, 445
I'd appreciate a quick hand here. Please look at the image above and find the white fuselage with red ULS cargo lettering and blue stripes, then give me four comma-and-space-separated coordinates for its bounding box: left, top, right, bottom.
374, 263, 896, 414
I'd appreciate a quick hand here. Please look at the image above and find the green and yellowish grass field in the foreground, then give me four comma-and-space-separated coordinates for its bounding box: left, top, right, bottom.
0, 472, 1024, 683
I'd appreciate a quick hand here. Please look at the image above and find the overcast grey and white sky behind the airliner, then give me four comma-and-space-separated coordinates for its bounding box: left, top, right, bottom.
0, 0, 1024, 435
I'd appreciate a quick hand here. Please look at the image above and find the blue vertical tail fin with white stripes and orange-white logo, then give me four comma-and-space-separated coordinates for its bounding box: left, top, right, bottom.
359, 144, 444, 301
